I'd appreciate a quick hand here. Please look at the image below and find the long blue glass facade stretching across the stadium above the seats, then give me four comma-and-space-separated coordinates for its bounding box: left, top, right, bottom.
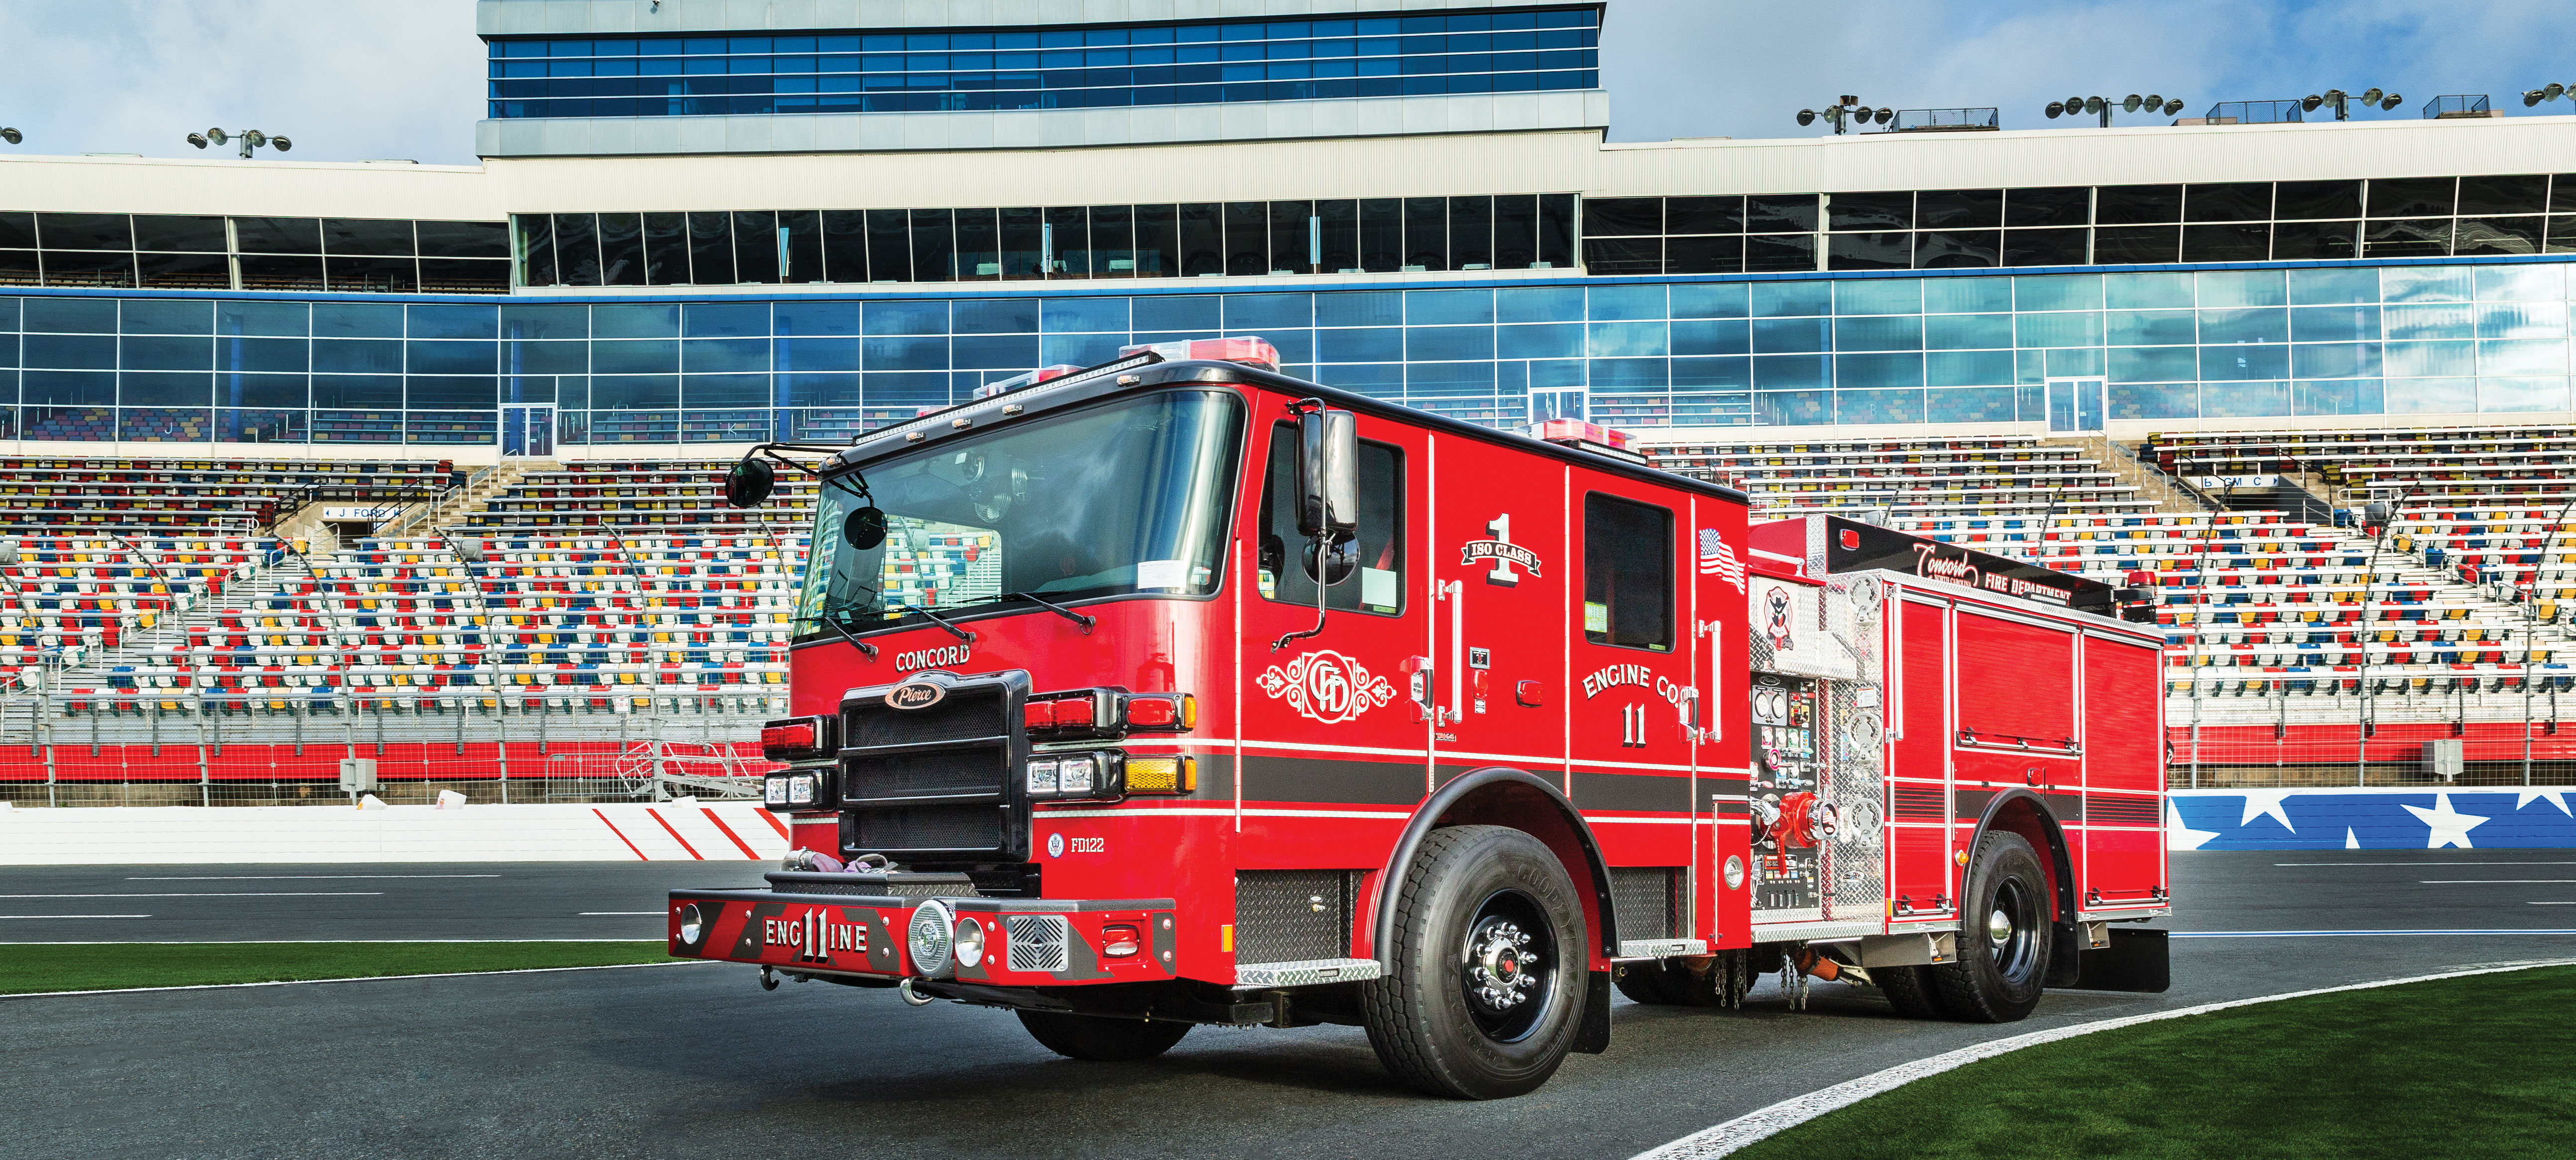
0, 258, 2571, 443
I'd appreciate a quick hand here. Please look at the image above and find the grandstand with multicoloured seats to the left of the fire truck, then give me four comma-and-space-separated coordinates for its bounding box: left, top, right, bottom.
0, 459, 814, 802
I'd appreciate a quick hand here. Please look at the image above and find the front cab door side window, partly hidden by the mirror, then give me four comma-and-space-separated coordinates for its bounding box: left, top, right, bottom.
1257, 423, 1404, 616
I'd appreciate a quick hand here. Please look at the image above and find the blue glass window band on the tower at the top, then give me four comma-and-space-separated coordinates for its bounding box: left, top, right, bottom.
487, 5, 1600, 119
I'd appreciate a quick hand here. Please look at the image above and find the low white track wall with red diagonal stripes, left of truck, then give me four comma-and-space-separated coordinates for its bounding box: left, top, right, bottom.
0, 799, 791, 866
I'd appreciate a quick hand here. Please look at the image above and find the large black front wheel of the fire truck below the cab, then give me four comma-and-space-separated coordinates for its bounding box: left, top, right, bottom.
1360, 825, 1589, 1101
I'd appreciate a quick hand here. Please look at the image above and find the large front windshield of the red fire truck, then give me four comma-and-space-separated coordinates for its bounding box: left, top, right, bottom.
796, 392, 1244, 640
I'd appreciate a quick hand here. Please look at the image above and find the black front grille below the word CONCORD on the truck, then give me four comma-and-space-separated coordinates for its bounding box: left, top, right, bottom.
840, 670, 1028, 866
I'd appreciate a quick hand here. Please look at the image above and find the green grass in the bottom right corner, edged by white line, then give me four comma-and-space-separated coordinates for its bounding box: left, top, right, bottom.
1736, 964, 2576, 1160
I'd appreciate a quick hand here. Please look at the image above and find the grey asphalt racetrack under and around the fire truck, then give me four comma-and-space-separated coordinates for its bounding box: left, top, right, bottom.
0, 851, 2576, 1160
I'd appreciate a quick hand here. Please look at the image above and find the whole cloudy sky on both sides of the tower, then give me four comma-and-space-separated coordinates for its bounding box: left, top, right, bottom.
0, 0, 2576, 165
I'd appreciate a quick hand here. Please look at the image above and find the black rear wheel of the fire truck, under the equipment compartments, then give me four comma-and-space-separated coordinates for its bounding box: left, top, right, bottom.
1929, 830, 2053, 1024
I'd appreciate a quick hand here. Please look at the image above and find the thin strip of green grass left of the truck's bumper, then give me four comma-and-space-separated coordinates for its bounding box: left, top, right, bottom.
0, 938, 670, 995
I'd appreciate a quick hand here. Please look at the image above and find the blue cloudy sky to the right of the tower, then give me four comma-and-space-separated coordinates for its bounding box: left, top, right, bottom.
1602, 0, 2576, 142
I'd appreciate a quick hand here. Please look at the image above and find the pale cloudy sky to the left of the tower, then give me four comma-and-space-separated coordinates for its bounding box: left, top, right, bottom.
0, 0, 484, 162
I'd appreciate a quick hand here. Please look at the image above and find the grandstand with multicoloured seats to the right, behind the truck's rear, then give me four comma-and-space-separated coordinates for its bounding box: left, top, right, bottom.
1641, 425, 2576, 783
